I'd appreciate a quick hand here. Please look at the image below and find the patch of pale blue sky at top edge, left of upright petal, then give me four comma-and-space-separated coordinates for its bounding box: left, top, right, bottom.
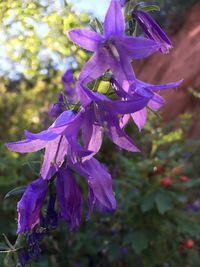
68, 0, 110, 19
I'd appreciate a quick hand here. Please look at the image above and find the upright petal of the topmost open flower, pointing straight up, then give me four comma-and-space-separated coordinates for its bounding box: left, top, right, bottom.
104, 0, 125, 38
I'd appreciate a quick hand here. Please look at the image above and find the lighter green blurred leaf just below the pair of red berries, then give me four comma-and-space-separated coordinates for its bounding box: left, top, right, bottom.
155, 192, 173, 214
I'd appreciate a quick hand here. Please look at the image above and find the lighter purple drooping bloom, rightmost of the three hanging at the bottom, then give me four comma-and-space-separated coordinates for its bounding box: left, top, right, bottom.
69, 158, 116, 219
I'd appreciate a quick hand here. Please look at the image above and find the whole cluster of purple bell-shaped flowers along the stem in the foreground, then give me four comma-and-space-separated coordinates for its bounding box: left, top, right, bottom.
7, 0, 181, 239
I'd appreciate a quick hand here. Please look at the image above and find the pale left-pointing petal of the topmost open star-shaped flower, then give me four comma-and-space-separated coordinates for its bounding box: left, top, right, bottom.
68, 29, 103, 52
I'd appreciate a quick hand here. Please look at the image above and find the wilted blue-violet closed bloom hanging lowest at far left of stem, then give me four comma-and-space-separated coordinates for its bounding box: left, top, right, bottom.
17, 177, 48, 234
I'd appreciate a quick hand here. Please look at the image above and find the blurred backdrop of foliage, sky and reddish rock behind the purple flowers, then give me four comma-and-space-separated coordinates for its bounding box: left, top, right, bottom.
0, 0, 200, 267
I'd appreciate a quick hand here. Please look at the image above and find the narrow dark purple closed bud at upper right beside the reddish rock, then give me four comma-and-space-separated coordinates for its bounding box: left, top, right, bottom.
133, 10, 173, 54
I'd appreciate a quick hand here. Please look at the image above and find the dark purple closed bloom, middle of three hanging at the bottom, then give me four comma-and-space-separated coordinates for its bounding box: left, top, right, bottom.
56, 167, 83, 229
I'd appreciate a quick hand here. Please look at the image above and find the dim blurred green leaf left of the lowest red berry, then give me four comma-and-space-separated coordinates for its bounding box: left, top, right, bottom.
131, 232, 148, 255
